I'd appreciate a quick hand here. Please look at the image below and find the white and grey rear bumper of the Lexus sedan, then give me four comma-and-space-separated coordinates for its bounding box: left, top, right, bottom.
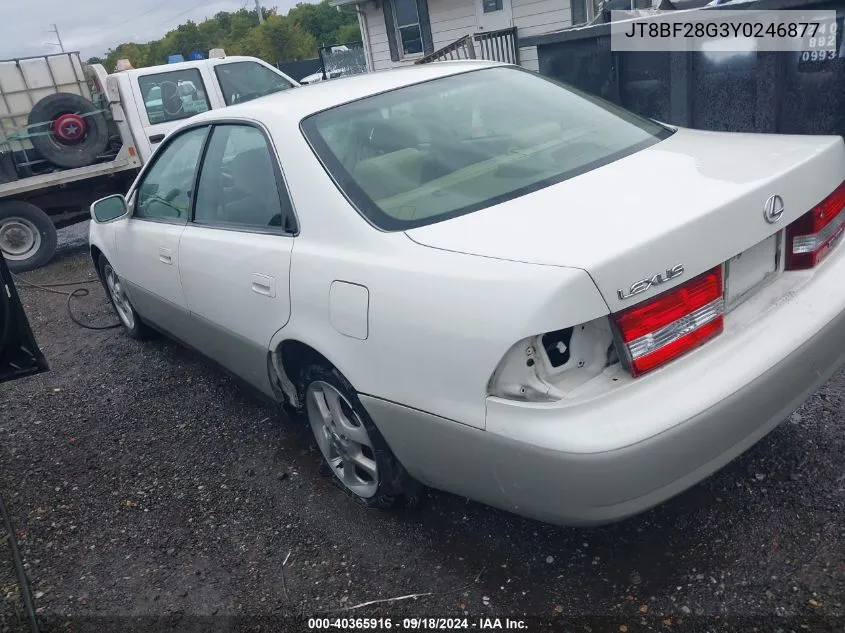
362, 244, 845, 525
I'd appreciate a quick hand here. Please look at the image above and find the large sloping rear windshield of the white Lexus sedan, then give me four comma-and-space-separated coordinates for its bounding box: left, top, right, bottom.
302, 68, 671, 230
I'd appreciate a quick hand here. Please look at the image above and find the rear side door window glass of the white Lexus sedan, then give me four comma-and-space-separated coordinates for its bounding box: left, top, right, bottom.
194, 125, 292, 230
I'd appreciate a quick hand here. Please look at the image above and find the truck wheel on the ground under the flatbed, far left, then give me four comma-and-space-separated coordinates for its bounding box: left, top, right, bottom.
0, 200, 58, 273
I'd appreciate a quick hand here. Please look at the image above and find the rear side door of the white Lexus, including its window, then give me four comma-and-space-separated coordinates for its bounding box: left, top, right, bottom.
179, 123, 296, 395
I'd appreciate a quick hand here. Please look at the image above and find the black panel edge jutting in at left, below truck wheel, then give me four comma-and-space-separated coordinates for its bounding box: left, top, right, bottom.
0, 254, 49, 382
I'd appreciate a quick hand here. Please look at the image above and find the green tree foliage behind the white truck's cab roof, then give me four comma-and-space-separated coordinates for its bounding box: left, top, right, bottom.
96, 0, 361, 72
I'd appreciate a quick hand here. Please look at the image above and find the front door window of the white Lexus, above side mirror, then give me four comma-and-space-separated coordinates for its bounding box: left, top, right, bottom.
134, 127, 208, 222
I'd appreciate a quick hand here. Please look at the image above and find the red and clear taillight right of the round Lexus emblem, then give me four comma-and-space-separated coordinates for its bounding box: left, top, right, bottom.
786, 183, 845, 270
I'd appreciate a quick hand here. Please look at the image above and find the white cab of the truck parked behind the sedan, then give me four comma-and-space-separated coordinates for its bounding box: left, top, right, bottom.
106, 56, 299, 163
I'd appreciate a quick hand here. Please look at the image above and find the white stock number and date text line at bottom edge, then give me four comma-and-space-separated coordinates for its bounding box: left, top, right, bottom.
308, 617, 528, 631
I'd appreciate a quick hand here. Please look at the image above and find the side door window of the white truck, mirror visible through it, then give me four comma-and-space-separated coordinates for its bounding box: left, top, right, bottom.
138, 68, 211, 125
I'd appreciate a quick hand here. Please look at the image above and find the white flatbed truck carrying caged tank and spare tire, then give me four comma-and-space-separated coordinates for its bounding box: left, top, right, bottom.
0, 49, 299, 272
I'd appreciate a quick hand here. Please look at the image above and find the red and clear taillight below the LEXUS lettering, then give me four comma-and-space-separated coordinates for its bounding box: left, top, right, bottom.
613, 266, 725, 376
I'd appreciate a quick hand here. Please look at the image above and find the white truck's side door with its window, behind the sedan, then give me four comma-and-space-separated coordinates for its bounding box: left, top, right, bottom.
131, 64, 223, 161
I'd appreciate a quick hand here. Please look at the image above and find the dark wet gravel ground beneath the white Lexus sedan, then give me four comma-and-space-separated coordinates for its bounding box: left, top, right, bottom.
0, 227, 845, 632
